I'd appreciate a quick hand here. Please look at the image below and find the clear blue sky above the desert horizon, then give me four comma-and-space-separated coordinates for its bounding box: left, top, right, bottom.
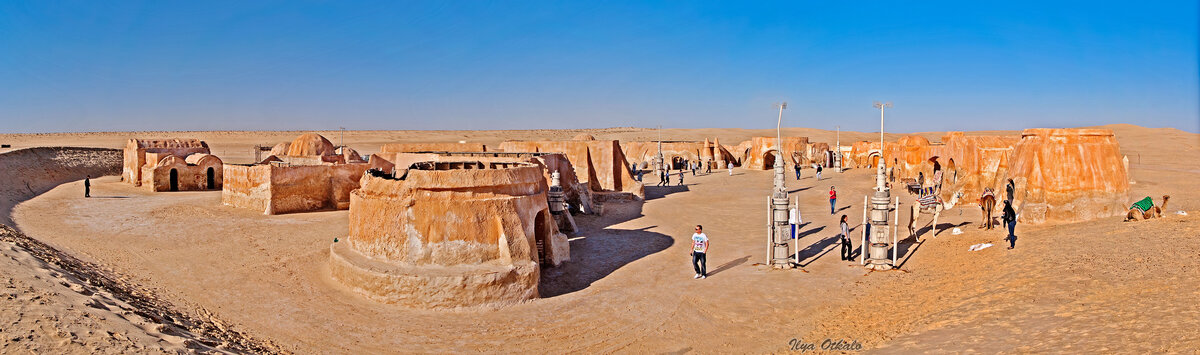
0, 0, 1200, 132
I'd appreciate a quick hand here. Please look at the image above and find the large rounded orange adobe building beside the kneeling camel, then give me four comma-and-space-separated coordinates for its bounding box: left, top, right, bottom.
1008, 128, 1129, 224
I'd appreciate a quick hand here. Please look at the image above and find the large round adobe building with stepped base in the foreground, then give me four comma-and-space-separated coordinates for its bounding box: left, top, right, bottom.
330, 163, 561, 308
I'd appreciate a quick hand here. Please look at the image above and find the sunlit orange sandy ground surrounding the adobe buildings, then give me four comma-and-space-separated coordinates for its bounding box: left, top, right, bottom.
0, 125, 1200, 353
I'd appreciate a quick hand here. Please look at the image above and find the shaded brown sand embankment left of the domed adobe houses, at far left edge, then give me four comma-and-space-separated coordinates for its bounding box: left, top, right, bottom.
0, 146, 122, 225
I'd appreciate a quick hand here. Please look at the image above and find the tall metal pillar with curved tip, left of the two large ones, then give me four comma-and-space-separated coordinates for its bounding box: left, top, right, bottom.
768, 102, 794, 269
